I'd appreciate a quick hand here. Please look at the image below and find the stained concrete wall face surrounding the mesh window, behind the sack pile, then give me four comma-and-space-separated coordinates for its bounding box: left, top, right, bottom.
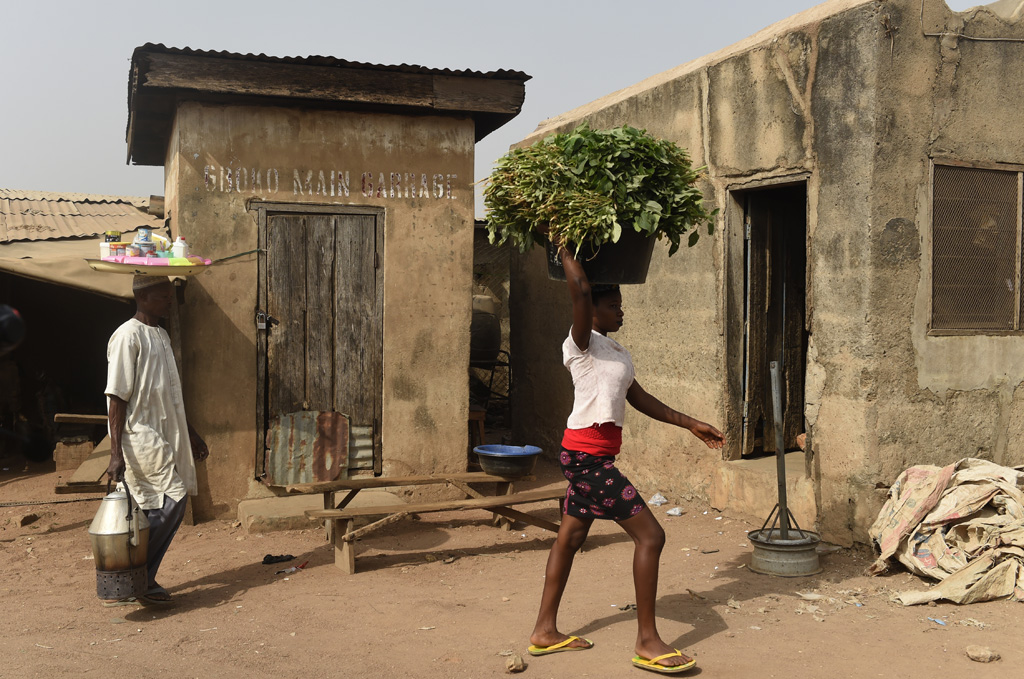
849, 0, 1024, 540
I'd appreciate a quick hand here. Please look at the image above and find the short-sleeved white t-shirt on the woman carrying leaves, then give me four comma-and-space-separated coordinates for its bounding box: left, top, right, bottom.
562, 330, 636, 429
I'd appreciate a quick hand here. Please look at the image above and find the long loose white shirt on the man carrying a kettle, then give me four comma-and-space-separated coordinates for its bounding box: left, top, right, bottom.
103, 319, 198, 509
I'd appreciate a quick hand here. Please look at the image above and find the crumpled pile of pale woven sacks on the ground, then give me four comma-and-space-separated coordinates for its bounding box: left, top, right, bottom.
868, 458, 1024, 605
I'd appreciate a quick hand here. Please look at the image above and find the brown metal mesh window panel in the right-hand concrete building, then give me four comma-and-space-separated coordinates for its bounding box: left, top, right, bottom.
931, 164, 1024, 334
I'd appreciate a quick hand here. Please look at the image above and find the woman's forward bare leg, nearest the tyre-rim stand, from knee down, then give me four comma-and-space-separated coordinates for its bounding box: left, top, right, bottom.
618, 508, 689, 667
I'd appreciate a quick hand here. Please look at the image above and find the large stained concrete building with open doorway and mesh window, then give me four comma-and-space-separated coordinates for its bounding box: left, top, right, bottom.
512, 0, 1024, 544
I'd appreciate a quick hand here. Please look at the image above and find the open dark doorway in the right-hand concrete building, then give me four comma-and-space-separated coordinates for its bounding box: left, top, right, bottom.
734, 182, 808, 458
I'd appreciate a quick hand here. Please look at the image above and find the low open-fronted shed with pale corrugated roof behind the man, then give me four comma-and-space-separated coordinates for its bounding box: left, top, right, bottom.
0, 188, 164, 462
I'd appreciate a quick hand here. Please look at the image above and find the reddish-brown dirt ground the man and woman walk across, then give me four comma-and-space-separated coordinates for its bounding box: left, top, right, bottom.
0, 461, 1024, 679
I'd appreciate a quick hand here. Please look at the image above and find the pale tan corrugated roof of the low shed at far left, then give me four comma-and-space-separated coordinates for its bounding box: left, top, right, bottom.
0, 188, 164, 243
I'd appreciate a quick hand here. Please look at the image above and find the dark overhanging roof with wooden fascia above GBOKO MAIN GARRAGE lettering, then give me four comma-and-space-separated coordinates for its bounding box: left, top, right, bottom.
125, 43, 529, 165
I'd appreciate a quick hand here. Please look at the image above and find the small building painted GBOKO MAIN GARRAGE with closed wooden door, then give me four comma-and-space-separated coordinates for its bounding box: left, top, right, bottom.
128, 45, 528, 518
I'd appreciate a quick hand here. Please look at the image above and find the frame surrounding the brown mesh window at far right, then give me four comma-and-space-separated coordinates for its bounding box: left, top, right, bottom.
923, 157, 1024, 337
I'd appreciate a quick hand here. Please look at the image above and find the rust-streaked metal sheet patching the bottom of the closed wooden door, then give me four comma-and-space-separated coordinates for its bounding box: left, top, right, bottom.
265, 411, 349, 485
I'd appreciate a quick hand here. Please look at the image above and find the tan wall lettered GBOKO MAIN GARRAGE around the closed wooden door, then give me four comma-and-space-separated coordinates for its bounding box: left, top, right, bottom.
166, 102, 473, 517
